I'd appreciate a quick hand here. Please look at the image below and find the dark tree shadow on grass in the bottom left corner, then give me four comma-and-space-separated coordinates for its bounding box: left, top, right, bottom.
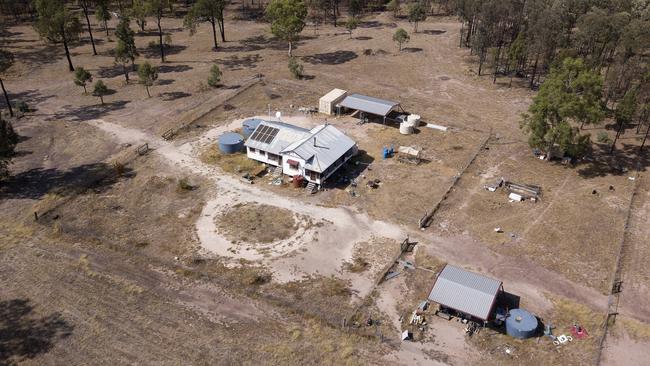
0, 299, 74, 365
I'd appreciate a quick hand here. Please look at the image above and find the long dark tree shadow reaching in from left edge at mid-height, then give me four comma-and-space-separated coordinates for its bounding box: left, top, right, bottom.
0, 162, 135, 199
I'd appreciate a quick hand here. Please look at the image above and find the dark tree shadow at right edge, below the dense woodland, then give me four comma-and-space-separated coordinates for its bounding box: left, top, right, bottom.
576, 135, 650, 178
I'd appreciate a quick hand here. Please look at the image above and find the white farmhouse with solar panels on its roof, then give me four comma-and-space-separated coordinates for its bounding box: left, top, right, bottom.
245, 121, 358, 185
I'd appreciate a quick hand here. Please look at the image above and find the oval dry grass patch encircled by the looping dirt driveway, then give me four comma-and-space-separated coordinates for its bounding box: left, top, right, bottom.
215, 203, 298, 243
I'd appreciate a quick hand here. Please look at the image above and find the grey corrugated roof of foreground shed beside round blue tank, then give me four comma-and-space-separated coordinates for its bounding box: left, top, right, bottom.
429, 264, 503, 320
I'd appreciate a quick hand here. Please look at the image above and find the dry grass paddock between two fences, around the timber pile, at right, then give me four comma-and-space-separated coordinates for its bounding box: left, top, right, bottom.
433, 145, 632, 293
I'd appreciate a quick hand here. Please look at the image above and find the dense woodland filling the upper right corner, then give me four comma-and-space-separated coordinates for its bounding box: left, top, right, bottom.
450, 0, 650, 155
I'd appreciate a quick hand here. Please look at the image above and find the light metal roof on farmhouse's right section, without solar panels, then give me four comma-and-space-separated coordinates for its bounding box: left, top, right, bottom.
282, 125, 356, 173
